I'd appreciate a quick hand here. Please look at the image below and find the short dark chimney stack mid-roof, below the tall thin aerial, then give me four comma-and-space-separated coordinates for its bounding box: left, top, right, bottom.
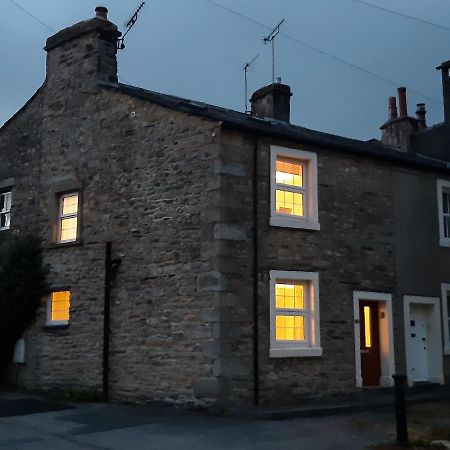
250, 78, 292, 122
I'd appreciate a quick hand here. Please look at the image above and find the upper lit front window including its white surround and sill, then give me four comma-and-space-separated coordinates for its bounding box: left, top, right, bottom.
270, 146, 320, 230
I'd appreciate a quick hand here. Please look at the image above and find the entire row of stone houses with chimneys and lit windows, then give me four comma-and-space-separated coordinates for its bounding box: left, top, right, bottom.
0, 8, 450, 405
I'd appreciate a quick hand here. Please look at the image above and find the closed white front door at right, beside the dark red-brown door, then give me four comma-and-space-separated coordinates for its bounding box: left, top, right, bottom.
409, 304, 431, 381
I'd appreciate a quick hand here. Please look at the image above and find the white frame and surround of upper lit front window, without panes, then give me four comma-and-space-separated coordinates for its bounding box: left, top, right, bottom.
270, 145, 320, 230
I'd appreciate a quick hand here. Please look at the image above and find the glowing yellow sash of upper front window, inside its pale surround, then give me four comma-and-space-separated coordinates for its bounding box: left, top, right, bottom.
275, 157, 305, 217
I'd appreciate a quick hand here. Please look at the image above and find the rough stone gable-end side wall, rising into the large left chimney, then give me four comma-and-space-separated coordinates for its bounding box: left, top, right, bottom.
0, 16, 229, 404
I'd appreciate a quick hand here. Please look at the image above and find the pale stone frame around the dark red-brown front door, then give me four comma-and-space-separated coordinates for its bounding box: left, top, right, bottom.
353, 291, 395, 387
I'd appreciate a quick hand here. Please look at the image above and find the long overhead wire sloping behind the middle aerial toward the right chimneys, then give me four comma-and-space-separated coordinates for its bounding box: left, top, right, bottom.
204, 0, 442, 104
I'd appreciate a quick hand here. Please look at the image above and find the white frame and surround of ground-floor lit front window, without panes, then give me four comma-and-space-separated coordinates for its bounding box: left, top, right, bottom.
269, 270, 322, 358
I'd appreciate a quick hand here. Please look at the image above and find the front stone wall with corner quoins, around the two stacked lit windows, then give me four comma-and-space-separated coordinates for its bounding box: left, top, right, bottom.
216, 132, 395, 403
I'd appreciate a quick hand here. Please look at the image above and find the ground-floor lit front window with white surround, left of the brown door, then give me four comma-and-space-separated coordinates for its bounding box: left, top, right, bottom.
269, 270, 322, 358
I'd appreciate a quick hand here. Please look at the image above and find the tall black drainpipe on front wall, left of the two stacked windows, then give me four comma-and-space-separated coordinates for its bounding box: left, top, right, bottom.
253, 136, 259, 406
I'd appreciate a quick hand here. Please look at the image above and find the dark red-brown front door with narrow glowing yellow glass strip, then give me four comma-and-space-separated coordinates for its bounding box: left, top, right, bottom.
359, 301, 381, 386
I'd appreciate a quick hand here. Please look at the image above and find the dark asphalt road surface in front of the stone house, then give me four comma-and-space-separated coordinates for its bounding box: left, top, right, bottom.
0, 386, 448, 450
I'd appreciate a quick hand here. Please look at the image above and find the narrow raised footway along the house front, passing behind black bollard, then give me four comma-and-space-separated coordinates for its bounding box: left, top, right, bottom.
224, 385, 450, 420
